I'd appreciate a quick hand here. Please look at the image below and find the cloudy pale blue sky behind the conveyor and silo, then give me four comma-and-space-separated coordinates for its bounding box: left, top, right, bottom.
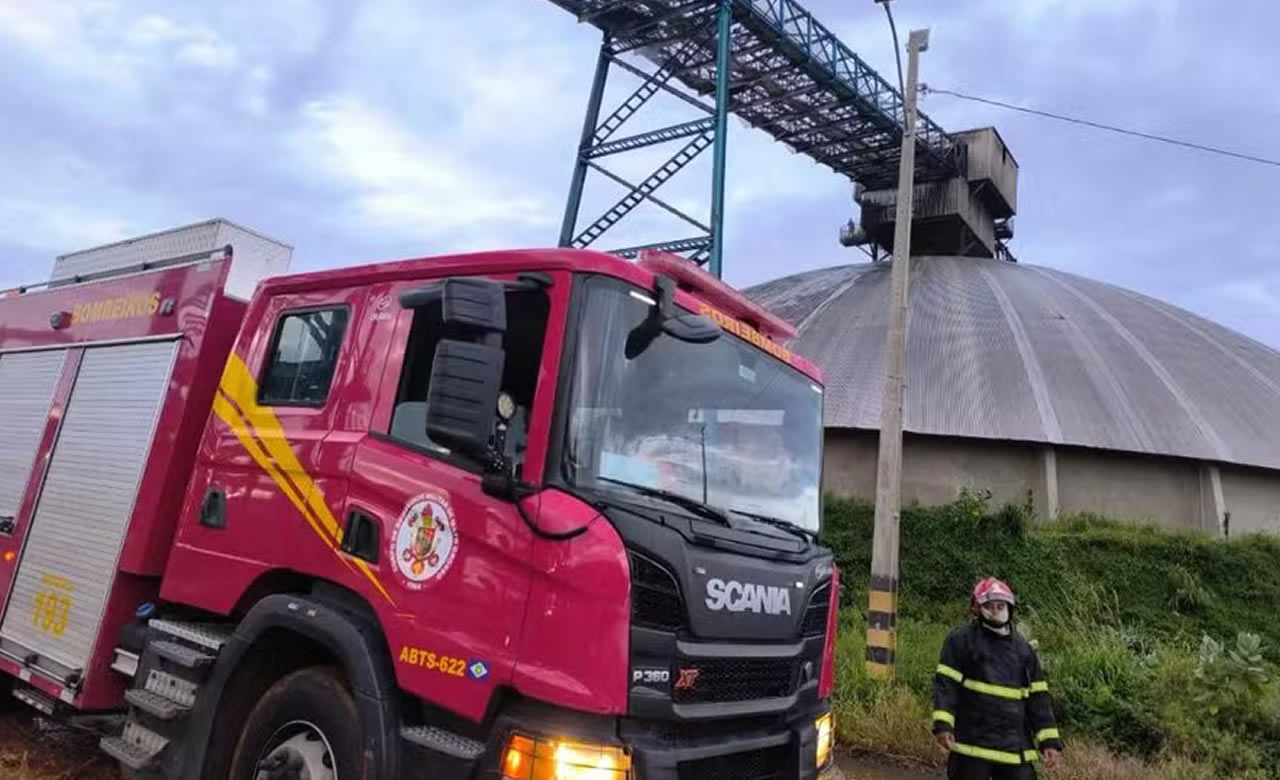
0, 0, 1280, 347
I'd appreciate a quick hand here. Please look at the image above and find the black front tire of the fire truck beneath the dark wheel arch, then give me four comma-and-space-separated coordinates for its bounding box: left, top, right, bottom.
228, 666, 367, 780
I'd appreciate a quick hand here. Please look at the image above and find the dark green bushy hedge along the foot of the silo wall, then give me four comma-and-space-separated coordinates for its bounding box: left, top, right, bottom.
823, 492, 1280, 662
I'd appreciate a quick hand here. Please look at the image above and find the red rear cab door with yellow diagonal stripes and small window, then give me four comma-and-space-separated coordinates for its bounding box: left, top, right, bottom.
163, 287, 366, 601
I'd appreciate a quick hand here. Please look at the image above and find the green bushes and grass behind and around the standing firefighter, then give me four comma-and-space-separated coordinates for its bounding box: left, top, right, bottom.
824, 493, 1280, 780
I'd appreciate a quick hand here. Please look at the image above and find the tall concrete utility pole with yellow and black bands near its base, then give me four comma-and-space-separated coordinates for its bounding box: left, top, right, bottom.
867, 29, 929, 680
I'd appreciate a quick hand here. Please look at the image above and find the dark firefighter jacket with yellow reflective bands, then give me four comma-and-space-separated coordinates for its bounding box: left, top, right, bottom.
933, 620, 1062, 763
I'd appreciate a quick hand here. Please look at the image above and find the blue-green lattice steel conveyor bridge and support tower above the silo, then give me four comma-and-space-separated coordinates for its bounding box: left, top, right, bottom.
552, 0, 964, 275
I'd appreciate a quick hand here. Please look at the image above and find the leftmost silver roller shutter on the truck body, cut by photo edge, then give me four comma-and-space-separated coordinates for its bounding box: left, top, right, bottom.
0, 350, 67, 519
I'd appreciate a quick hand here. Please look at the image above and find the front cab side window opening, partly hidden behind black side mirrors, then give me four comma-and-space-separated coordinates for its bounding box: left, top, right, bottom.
389, 291, 550, 479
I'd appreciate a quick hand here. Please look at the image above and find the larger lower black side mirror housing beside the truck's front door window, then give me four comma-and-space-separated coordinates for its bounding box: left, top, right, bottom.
426, 338, 506, 459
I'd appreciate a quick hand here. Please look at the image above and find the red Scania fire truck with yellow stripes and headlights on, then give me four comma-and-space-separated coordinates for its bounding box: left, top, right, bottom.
0, 226, 838, 780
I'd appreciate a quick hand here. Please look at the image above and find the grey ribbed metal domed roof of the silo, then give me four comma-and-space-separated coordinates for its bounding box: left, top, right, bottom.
746, 257, 1280, 469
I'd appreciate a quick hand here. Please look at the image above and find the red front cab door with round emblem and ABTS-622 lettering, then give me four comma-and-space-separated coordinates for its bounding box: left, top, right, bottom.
346, 278, 567, 719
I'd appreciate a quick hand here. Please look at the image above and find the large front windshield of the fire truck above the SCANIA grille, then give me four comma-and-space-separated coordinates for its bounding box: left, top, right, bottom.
564, 278, 822, 532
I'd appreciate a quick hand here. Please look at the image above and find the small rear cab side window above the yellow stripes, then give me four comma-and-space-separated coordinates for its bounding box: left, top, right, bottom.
259, 307, 348, 406
